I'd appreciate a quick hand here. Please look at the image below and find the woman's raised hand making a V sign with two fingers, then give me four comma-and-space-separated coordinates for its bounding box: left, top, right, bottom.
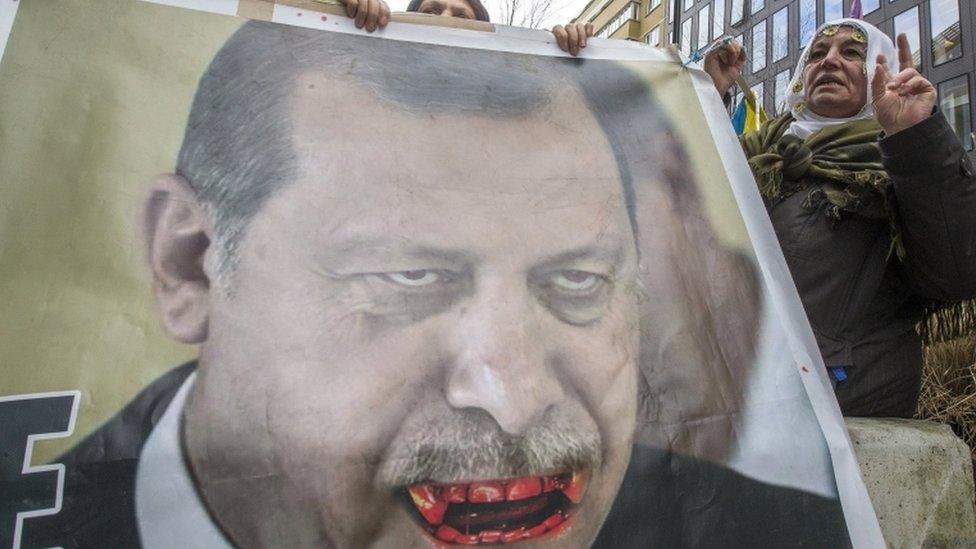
871, 34, 936, 135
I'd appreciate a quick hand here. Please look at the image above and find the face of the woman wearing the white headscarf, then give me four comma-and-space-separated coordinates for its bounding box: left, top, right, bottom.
803, 27, 868, 118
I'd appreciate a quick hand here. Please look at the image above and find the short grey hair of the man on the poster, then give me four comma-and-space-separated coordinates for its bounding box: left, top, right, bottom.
176, 21, 694, 273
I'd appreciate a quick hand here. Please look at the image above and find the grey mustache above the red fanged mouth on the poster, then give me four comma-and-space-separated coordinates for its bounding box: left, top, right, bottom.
378, 402, 603, 487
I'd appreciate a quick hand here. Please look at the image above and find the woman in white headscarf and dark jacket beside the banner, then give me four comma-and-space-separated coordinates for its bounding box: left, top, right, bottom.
705, 19, 976, 417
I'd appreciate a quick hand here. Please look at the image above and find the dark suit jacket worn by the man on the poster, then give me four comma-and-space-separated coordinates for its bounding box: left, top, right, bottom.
23, 363, 850, 549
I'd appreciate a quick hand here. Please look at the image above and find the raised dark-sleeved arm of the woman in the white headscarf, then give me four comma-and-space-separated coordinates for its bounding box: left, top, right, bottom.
881, 112, 976, 301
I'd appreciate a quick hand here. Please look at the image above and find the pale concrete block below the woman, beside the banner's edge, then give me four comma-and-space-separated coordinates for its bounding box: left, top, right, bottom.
846, 418, 976, 548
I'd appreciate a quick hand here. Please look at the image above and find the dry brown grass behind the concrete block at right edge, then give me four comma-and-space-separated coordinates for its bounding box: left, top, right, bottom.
916, 335, 976, 460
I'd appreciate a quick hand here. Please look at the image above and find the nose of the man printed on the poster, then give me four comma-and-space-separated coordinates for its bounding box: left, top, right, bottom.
447, 285, 563, 435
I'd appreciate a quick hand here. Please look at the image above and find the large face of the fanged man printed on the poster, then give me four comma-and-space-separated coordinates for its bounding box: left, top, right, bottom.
177, 70, 637, 547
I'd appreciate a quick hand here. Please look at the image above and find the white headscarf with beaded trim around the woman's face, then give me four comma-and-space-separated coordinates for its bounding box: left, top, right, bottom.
786, 18, 898, 139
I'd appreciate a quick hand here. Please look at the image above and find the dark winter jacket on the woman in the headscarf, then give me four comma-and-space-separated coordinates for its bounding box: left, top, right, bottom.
766, 112, 976, 417
